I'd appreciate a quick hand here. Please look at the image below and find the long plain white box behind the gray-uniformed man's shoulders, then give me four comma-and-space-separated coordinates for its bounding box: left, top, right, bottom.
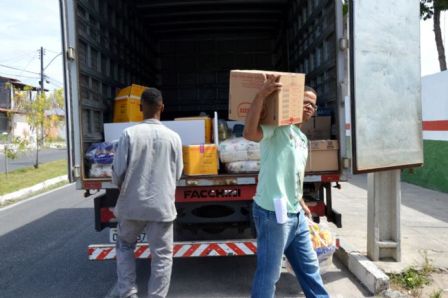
104, 120, 205, 145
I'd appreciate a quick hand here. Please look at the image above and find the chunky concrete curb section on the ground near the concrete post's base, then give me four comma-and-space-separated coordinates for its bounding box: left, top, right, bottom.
335, 239, 389, 295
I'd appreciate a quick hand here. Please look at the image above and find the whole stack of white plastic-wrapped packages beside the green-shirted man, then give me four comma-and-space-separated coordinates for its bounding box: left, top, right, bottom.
219, 137, 260, 173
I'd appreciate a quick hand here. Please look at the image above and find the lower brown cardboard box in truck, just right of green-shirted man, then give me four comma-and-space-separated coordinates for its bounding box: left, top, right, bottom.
305, 140, 339, 172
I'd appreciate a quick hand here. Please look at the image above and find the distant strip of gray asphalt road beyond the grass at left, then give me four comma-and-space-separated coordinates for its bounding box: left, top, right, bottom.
0, 149, 67, 173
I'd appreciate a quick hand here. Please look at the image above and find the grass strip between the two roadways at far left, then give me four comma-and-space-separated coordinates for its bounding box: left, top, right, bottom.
0, 160, 67, 195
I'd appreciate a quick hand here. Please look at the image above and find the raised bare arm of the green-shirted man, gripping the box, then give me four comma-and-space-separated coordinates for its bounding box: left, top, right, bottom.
243, 75, 282, 142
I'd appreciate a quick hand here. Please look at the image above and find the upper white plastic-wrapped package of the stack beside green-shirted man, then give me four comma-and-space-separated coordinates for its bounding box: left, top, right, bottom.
219, 138, 260, 163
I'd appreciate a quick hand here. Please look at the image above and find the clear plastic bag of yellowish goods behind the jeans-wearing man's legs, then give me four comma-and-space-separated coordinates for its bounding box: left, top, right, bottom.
308, 219, 336, 262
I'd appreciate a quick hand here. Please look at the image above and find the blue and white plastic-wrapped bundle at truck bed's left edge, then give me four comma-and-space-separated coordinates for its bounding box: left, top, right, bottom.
86, 141, 118, 178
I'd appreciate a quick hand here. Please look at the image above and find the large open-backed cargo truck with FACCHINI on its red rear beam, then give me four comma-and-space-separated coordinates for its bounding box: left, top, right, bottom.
60, 0, 422, 260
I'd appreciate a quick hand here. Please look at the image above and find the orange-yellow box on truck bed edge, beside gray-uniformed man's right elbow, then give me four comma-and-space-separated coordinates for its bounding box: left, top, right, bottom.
182, 144, 218, 176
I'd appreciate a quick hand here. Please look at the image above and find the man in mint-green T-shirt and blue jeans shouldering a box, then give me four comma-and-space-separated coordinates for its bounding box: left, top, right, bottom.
244, 75, 329, 298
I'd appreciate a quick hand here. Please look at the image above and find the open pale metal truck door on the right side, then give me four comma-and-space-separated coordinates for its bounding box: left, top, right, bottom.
349, 0, 423, 174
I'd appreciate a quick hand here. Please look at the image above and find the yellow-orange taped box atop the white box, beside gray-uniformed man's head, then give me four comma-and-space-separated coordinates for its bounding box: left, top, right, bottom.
113, 84, 146, 122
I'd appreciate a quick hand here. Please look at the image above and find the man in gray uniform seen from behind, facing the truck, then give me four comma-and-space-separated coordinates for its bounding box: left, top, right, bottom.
112, 88, 183, 298
